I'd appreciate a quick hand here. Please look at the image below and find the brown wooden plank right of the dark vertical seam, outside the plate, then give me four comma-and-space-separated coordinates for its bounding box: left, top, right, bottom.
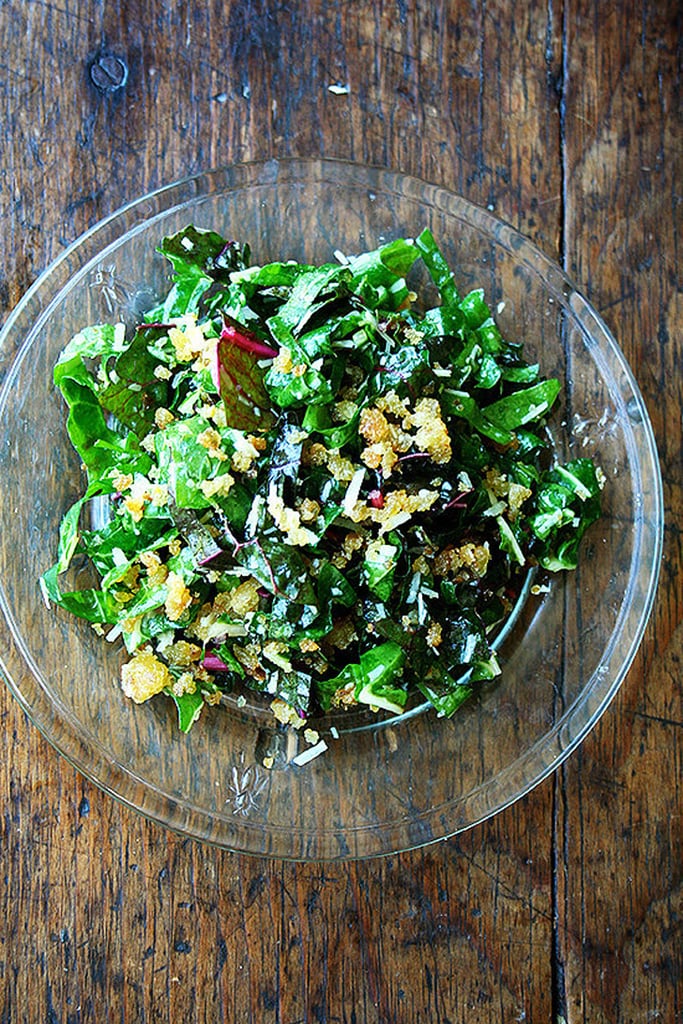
557, 3, 683, 1024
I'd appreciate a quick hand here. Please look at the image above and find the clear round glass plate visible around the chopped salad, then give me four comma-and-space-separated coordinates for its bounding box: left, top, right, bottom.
0, 160, 664, 860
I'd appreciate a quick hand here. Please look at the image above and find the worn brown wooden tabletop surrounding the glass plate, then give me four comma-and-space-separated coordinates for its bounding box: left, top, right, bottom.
0, 0, 683, 1024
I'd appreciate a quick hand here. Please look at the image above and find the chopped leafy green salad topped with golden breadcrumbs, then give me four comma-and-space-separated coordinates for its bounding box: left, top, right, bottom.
41, 226, 602, 731
